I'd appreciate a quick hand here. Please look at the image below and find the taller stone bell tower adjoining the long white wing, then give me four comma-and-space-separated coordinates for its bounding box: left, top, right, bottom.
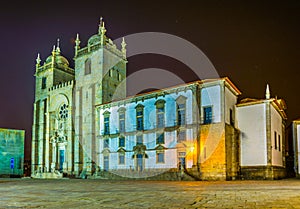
74, 18, 127, 175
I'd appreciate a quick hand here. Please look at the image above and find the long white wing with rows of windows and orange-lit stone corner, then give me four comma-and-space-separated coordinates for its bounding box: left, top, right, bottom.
96, 78, 240, 179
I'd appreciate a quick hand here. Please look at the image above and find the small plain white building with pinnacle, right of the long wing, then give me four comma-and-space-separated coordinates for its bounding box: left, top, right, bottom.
236, 86, 287, 179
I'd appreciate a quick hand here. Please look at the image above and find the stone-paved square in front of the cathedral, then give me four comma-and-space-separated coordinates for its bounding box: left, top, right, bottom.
0, 179, 300, 209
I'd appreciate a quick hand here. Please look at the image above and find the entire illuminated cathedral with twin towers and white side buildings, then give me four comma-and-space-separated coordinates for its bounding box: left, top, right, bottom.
31, 20, 286, 180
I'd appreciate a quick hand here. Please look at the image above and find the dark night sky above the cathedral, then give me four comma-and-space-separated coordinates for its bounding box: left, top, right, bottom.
0, 0, 300, 159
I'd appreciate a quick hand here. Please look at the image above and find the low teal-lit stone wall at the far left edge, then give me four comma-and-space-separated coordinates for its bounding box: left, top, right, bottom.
0, 128, 25, 176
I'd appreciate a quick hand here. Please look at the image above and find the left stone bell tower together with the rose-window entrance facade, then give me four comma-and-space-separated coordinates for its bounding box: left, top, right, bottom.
31, 40, 74, 177
